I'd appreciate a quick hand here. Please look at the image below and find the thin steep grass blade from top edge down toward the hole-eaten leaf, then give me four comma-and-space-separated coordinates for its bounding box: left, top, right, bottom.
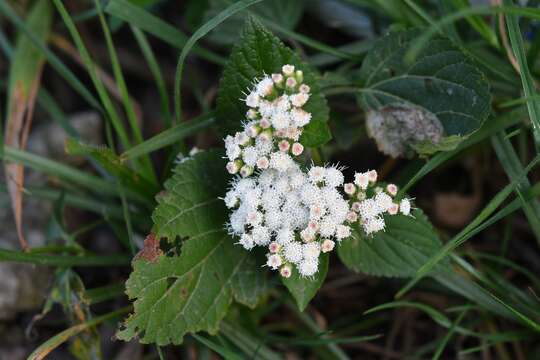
94, 0, 157, 184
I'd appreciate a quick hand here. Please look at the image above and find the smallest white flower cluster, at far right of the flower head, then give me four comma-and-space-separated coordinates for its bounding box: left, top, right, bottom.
343, 170, 411, 235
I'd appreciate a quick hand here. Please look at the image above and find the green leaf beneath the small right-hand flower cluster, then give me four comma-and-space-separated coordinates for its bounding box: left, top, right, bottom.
337, 210, 447, 277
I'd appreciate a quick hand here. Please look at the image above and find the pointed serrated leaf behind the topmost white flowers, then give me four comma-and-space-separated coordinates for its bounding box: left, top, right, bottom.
217, 18, 331, 147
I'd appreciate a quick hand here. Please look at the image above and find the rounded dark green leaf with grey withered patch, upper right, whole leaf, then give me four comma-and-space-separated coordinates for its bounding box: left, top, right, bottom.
359, 30, 491, 157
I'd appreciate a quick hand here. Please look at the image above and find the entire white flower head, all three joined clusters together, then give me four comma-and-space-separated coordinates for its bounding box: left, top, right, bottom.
220, 65, 411, 278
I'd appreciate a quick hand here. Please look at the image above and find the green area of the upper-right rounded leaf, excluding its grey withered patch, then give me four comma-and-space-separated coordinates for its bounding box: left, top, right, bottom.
359, 30, 491, 155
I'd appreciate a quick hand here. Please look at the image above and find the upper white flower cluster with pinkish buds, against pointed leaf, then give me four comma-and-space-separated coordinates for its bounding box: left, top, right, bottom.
225, 65, 311, 177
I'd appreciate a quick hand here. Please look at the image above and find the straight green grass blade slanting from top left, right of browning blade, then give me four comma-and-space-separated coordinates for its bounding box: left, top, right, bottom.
53, 0, 130, 149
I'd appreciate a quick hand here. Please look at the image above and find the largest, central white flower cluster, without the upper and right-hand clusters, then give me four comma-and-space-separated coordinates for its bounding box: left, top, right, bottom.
225, 163, 351, 277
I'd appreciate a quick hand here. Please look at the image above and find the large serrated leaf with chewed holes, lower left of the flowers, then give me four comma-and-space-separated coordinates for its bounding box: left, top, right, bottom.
118, 151, 266, 345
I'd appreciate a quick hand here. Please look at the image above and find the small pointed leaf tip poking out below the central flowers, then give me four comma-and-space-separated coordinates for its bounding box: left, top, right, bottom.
281, 253, 329, 311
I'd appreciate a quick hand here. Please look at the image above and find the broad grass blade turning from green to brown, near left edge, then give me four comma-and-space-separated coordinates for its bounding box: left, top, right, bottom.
4, 1, 53, 249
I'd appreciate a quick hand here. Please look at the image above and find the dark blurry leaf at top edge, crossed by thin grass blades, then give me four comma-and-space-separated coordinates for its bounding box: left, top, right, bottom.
204, 0, 305, 45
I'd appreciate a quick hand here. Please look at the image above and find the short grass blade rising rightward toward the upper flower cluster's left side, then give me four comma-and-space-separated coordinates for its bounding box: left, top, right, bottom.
120, 112, 216, 160
